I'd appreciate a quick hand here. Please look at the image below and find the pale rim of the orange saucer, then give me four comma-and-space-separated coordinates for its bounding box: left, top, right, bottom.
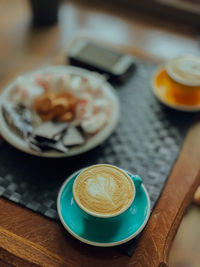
151, 65, 200, 112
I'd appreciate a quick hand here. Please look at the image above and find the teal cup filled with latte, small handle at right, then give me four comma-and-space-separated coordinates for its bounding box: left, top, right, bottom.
72, 164, 142, 222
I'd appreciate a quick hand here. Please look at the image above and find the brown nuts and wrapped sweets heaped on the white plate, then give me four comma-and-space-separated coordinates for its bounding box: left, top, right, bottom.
2, 71, 113, 153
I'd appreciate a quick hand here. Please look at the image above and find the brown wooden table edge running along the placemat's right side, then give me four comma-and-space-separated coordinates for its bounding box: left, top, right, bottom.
132, 123, 200, 266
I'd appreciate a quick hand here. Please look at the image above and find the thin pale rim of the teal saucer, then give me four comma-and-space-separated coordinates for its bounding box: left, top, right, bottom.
57, 169, 151, 247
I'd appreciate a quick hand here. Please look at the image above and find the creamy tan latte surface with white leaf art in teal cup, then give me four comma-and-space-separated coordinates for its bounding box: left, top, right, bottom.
73, 165, 134, 218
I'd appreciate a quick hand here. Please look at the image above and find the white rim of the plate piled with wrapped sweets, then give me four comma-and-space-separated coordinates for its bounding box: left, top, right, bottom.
0, 66, 119, 158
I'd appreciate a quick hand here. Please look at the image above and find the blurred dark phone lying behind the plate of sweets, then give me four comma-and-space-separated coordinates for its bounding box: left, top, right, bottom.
68, 39, 135, 82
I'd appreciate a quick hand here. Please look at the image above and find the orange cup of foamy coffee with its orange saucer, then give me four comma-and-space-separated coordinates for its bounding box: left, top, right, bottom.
152, 55, 200, 107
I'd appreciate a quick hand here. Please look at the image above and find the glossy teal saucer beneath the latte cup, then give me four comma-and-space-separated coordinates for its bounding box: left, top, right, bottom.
57, 171, 150, 247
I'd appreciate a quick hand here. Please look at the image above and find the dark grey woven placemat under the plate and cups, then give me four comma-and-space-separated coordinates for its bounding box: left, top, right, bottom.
0, 62, 193, 256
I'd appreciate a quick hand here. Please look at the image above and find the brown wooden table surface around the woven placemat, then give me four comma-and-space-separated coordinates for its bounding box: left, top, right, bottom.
0, 0, 200, 267
